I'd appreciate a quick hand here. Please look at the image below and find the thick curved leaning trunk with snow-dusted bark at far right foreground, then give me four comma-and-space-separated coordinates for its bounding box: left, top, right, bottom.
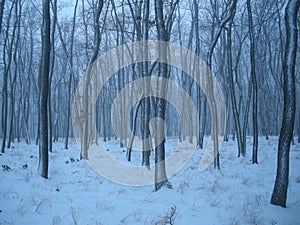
271, 0, 300, 207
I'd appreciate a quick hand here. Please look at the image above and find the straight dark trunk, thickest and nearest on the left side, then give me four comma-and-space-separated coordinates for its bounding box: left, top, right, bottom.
38, 0, 51, 179
